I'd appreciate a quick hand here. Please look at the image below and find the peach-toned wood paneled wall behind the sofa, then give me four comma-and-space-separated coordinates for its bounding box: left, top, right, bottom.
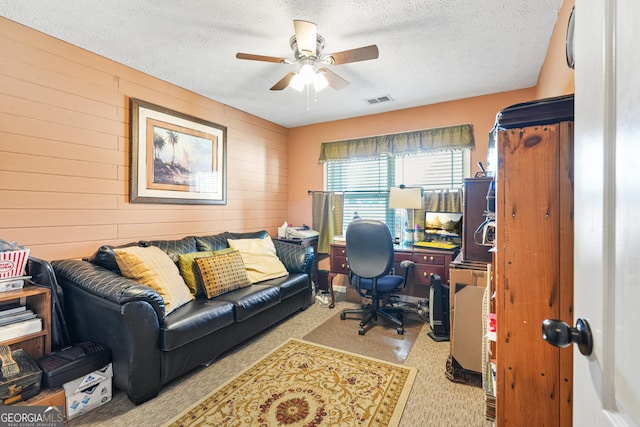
0, 17, 288, 260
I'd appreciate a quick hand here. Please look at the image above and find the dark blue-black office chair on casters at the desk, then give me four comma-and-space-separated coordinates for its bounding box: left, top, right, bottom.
340, 219, 412, 335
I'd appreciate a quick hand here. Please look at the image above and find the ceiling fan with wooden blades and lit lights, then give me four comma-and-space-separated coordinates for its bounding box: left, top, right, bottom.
236, 20, 378, 91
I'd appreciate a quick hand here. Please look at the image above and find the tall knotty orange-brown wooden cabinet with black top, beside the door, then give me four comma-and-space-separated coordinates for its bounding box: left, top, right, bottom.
493, 96, 574, 427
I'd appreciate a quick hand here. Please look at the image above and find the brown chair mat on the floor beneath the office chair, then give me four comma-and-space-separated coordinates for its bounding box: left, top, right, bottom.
303, 310, 424, 363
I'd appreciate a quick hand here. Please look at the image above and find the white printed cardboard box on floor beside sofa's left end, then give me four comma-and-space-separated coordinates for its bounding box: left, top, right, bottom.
62, 363, 113, 420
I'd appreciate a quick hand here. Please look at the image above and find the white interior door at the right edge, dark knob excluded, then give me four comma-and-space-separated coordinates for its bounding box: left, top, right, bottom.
573, 0, 640, 427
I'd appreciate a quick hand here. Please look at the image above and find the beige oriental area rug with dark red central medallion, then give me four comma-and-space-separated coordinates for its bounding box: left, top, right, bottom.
168, 338, 417, 427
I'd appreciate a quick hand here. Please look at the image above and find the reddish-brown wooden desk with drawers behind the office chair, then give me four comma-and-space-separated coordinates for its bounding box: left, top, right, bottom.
327, 243, 458, 308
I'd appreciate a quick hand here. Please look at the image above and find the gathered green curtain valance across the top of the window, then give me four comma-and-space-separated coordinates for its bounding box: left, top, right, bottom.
318, 123, 475, 163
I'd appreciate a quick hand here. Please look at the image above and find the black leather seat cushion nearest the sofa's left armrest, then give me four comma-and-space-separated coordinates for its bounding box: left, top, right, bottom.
160, 298, 234, 351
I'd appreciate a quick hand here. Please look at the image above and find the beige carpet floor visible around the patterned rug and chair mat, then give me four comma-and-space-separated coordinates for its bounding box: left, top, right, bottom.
65, 300, 492, 427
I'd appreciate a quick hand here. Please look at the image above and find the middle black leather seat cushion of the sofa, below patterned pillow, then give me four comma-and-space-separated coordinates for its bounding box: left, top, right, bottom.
216, 285, 281, 322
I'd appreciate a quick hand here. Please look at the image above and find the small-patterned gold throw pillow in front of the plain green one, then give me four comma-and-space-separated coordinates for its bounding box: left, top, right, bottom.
195, 250, 251, 298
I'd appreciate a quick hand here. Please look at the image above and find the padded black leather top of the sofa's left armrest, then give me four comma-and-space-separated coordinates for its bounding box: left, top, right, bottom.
51, 259, 165, 320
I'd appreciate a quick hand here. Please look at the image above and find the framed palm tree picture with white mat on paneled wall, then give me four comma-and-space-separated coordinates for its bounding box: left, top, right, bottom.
129, 98, 227, 205
